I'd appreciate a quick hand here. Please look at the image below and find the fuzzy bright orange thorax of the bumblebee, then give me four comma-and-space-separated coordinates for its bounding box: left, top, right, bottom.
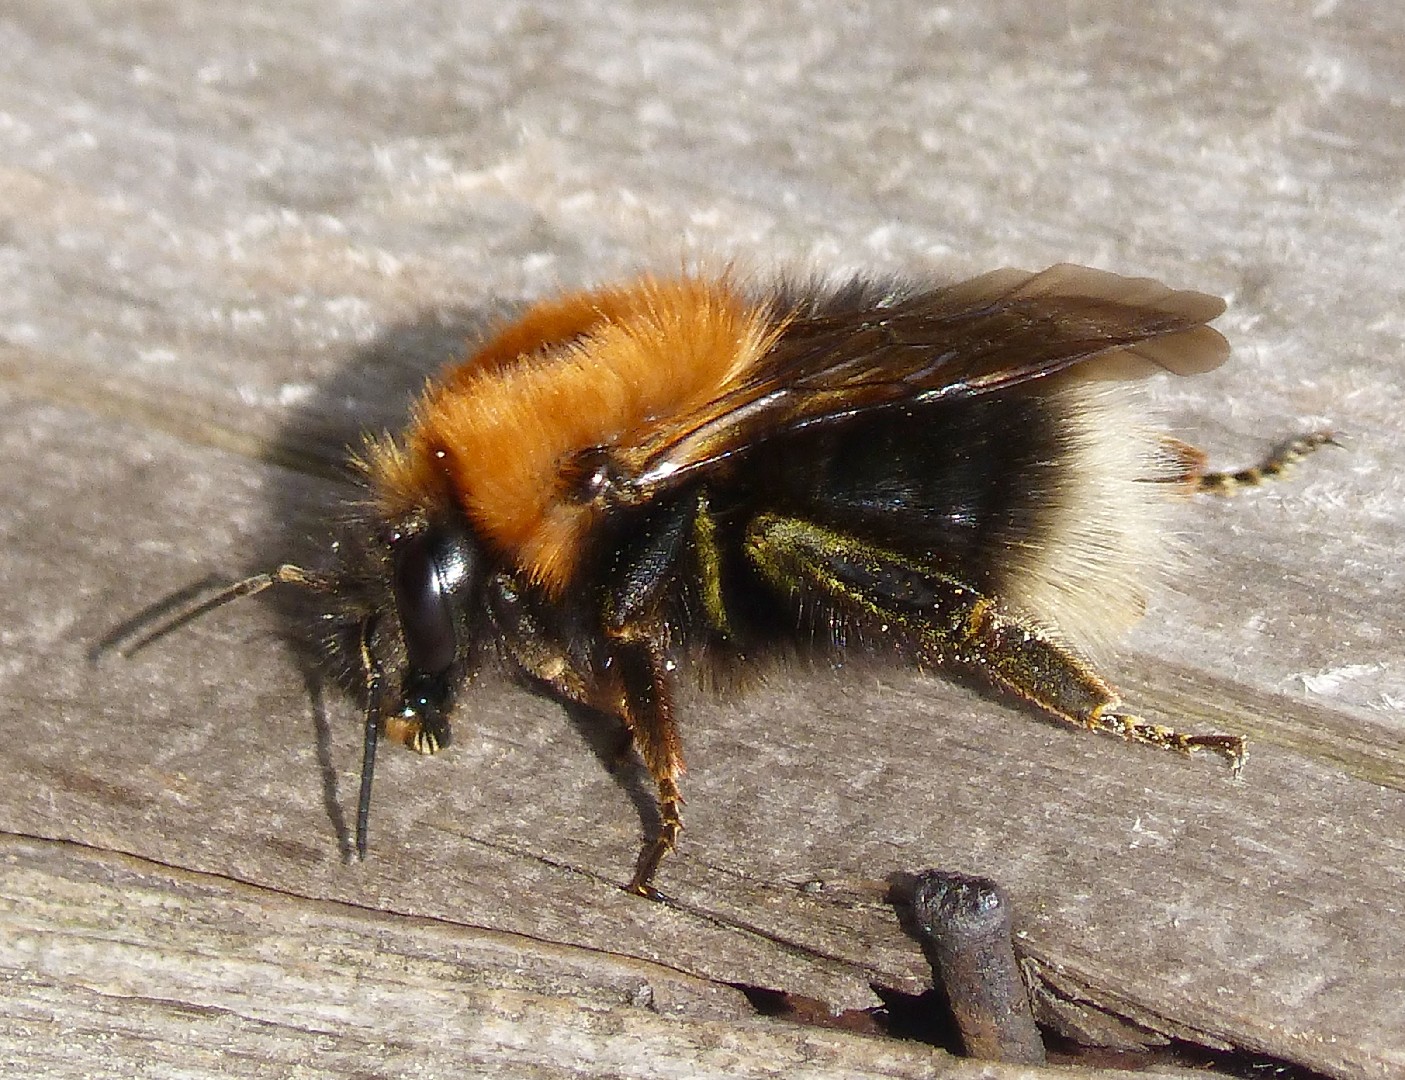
367, 269, 778, 594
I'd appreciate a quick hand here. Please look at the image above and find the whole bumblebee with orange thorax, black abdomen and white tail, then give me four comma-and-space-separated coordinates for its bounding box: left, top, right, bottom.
134, 265, 1329, 897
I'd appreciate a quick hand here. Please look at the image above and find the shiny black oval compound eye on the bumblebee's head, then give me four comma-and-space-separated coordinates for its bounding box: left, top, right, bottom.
391, 524, 476, 676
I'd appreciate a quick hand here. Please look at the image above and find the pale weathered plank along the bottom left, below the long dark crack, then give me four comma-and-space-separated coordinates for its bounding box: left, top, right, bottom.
16, 837, 1129, 1080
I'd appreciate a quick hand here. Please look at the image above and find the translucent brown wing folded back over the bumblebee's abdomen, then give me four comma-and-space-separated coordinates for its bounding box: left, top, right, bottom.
629, 264, 1229, 501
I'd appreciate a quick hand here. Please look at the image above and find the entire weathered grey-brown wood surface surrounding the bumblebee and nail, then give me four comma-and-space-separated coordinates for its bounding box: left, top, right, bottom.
0, 0, 1405, 1077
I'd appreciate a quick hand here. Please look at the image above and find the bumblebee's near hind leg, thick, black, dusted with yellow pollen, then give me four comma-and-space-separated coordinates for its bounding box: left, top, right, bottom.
746, 514, 1245, 772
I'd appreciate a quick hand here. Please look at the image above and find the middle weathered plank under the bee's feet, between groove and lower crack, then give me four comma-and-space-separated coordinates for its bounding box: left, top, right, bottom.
4, 393, 1405, 1066
